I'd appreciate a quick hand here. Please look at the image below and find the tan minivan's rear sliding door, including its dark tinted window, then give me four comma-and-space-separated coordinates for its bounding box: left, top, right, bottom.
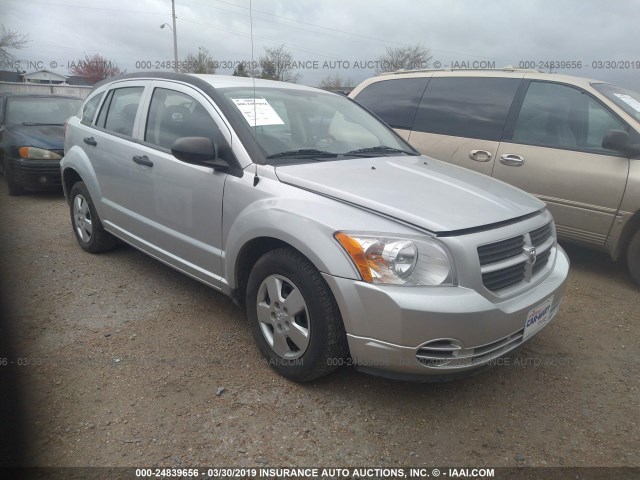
409, 76, 521, 175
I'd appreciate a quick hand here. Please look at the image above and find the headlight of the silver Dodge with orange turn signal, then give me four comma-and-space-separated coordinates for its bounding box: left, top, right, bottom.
334, 232, 454, 285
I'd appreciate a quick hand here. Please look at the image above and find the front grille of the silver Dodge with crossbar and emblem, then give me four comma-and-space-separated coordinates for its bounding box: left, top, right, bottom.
478, 222, 555, 292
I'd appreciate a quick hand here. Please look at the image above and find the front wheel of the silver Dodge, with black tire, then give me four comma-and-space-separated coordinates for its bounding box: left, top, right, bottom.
246, 248, 348, 382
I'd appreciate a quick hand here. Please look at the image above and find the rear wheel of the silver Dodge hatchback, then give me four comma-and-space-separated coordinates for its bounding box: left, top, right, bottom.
70, 182, 117, 253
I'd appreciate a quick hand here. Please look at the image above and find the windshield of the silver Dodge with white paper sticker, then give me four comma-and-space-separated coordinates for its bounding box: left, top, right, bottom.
221, 87, 418, 164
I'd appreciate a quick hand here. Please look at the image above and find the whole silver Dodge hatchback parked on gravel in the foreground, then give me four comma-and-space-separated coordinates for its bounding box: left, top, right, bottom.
61, 73, 569, 382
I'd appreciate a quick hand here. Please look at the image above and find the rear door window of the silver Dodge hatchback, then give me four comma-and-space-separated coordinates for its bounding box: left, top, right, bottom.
96, 87, 144, 136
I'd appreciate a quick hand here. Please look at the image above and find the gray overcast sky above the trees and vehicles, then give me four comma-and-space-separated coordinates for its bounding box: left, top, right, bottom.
0, 0, 640, 90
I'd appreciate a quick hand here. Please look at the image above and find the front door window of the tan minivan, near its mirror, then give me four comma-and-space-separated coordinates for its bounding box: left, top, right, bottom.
513, 82, 626, 153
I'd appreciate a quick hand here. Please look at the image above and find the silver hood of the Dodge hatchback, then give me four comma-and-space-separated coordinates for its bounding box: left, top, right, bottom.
276, 156, 545, 233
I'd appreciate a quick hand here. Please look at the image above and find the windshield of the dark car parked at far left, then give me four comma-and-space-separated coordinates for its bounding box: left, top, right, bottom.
5, 97, 82, 125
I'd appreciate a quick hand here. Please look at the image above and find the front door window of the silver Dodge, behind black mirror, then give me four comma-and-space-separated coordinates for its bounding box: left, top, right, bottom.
144, 88, 233, 160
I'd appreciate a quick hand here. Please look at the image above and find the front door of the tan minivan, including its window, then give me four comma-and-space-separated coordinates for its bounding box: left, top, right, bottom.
493, 81, 629, 247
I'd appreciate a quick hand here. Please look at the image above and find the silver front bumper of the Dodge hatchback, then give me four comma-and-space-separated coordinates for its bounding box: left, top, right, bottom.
324, 246, 569, 381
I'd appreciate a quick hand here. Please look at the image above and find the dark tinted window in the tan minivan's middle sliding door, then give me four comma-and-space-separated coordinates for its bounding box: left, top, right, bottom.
413, 77, 520, 141
